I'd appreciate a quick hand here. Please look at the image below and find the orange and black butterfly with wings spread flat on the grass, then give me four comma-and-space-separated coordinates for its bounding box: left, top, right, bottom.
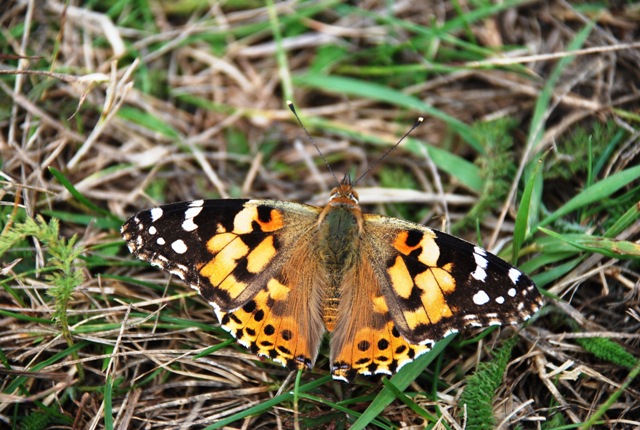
121, 176, 541, 382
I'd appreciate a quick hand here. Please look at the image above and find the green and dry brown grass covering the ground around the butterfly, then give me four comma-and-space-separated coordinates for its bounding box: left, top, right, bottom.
0, 0, 640, 429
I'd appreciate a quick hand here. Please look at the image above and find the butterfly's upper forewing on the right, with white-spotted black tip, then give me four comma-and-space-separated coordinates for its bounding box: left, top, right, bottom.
365, 215, 541, 345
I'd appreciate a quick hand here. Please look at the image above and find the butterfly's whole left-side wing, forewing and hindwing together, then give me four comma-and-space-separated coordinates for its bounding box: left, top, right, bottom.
122, 199, 324, 368
